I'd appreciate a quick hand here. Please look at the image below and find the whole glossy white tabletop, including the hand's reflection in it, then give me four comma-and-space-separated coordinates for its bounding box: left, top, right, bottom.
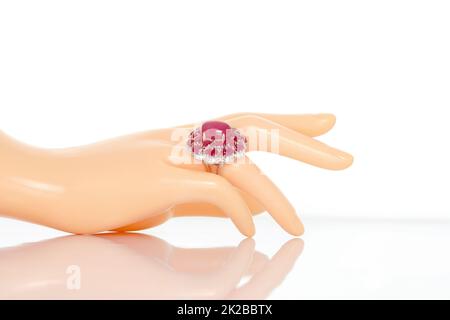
0, 215, 450, 299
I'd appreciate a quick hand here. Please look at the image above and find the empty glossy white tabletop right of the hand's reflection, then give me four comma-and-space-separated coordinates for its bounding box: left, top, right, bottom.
284, 218, 450, 299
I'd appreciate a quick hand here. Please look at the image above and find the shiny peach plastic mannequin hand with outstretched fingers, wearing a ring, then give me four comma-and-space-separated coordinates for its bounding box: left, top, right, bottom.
0, 114, 352, 236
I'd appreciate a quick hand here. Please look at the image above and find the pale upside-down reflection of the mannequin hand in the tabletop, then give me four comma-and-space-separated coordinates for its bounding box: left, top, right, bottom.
0, 233, 303, 299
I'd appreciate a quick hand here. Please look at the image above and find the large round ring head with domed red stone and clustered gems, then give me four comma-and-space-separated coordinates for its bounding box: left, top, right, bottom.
187, 121, 247, 165
